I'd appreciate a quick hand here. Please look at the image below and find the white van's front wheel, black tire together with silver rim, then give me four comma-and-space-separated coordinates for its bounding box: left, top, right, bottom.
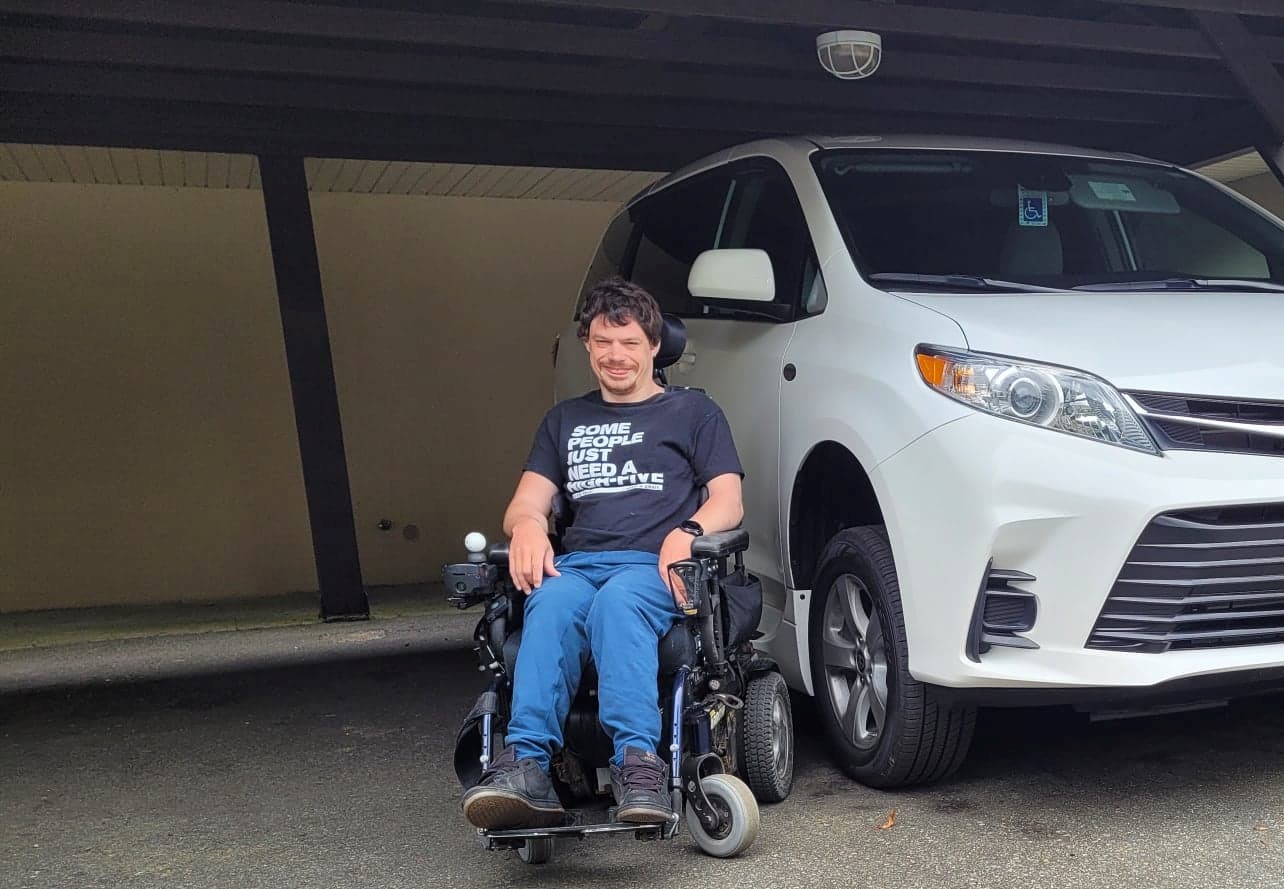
810, 527, 976, 788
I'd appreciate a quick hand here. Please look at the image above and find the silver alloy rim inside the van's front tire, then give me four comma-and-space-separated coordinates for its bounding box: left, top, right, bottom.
820, 574, 887, 749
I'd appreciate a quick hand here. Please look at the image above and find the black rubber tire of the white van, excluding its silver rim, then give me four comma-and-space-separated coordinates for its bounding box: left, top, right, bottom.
809, 525, 976, 789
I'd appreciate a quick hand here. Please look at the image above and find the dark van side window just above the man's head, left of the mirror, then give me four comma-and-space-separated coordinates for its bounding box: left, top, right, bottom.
632, 171, 727, 317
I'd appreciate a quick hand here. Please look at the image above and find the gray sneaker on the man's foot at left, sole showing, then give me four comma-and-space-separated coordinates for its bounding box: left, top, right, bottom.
464, 746, 566, 830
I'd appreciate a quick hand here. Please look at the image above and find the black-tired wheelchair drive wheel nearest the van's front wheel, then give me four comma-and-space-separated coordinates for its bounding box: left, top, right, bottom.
740, 671, 794, 803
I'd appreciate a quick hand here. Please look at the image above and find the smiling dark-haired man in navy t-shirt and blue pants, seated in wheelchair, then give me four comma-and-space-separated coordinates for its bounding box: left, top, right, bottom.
464, 277, 743, 829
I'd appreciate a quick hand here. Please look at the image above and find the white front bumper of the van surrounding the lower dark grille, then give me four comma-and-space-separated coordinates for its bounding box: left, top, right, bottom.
872, 414, 1284, 696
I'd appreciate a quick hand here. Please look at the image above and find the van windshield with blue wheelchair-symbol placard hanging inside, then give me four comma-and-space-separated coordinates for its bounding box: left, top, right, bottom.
813, 149, 1284, 292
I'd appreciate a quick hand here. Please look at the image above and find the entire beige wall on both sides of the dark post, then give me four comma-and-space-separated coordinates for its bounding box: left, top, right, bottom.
0, 182, 614, 612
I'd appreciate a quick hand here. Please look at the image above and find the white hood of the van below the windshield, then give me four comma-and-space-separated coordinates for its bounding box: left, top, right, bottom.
898, 290, 1284, 401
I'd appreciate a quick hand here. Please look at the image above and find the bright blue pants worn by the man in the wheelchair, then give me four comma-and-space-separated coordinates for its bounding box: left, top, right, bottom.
506, 551, 682, 771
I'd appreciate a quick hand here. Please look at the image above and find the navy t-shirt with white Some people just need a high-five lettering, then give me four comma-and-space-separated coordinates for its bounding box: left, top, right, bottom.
525, 389, 743, 552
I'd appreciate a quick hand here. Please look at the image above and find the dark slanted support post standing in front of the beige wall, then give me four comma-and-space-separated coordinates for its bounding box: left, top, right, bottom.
258, 155, 370, 621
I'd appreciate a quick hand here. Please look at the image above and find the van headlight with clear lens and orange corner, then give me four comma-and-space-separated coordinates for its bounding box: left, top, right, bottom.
915, 346, 1159, 455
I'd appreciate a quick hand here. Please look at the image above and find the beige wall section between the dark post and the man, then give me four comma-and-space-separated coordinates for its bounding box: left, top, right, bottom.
313, 194, 616, 583
